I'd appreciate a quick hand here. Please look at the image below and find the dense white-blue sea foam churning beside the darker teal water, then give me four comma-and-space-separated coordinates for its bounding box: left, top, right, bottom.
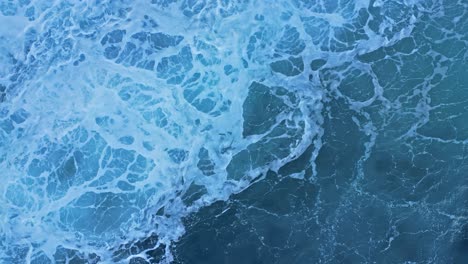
0, 0, 467, 264
